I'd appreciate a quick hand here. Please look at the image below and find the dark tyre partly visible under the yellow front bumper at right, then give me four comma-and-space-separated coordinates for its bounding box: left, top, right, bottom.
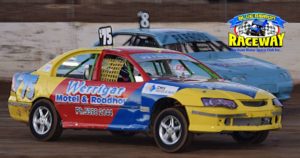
232, 131, 269, 144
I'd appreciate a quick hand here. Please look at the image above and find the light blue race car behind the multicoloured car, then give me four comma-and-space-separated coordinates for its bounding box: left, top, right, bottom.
95, 28, 293, 100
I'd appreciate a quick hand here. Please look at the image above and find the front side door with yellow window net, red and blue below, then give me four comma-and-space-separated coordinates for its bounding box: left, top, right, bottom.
91, 51, 144, 130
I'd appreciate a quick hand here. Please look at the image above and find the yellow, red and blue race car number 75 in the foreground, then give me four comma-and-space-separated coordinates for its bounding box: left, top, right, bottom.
8, 47, 283, 152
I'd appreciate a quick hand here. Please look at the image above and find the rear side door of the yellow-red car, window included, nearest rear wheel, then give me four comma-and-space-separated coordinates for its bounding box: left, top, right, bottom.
51, 52, 106, 128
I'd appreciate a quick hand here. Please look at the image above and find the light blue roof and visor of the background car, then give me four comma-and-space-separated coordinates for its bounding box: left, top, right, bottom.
113, 28, 219, 46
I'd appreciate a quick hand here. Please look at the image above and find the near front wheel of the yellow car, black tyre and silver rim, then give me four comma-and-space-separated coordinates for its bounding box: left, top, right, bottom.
153, 108, 193, 152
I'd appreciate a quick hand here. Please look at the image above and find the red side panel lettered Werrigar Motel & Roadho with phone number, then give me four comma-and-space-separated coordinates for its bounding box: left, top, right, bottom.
51, 79, 143, 129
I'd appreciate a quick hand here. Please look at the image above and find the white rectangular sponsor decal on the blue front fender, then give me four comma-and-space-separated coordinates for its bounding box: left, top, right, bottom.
142, 83, 179, 96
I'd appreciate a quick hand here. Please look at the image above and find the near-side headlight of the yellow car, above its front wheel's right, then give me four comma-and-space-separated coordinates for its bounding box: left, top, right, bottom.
201, 98, 237, 109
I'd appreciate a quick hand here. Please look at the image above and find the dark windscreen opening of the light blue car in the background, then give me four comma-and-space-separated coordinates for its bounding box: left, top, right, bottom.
164, 41, 230, 53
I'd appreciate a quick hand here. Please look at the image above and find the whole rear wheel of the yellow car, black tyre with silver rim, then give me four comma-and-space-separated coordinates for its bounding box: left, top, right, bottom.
29, 100, 63, 141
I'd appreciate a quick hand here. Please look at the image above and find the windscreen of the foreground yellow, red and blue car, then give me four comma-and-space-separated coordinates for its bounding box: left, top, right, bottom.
131, 53, 212, 79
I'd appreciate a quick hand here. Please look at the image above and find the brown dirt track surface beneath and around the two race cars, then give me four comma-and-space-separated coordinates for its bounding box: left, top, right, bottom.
0, 82, 300, 158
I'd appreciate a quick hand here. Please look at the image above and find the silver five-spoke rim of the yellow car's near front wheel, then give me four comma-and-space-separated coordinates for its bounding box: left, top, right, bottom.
159, 115, 182, 145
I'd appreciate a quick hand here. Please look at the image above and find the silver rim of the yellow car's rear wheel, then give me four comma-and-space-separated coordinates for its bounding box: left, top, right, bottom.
32, 106, 52, 135
